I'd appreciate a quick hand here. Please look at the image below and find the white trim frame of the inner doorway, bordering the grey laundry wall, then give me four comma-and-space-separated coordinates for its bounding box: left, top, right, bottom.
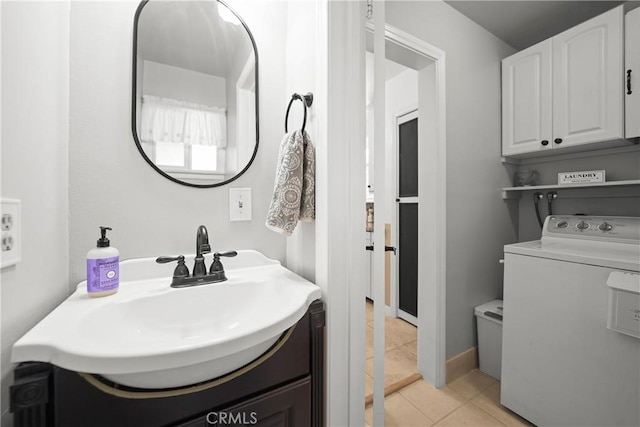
385, 24, 447, 387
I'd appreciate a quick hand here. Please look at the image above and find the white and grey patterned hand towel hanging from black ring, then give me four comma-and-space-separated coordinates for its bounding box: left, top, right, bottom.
266, 130, 316, 236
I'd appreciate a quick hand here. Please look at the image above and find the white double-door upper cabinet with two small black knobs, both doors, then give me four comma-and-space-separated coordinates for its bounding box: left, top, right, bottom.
502, 6, 624, 156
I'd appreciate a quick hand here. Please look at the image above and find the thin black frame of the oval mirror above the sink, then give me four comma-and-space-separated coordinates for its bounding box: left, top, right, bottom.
131, 0, 260, 188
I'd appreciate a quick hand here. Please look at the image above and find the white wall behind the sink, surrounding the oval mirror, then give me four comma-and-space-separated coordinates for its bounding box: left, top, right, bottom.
70, 0, 286, 286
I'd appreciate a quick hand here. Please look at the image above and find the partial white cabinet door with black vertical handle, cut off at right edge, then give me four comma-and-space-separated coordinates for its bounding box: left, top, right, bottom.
624, 8, 640, 138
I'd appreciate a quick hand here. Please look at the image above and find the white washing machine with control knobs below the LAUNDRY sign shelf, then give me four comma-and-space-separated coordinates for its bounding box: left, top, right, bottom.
501, 215, 640, 427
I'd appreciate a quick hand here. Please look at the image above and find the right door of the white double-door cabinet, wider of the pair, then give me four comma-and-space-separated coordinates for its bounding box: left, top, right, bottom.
552, 7, 623, 147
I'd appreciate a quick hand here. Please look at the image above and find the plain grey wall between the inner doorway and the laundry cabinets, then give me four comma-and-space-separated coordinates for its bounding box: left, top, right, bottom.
386, 1, 516, 357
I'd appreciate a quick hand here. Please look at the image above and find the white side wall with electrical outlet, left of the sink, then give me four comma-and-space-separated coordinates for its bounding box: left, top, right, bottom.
0, 1, 69, 427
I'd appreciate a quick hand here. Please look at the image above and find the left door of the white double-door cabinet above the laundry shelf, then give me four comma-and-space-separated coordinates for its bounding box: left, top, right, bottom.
502, 39, 552, 156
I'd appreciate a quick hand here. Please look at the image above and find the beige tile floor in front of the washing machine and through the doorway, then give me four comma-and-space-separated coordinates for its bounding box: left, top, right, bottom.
365, 303, 532, 427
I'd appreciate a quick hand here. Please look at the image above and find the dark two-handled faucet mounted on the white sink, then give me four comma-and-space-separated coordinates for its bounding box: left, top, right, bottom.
156, 225, 238, 288
